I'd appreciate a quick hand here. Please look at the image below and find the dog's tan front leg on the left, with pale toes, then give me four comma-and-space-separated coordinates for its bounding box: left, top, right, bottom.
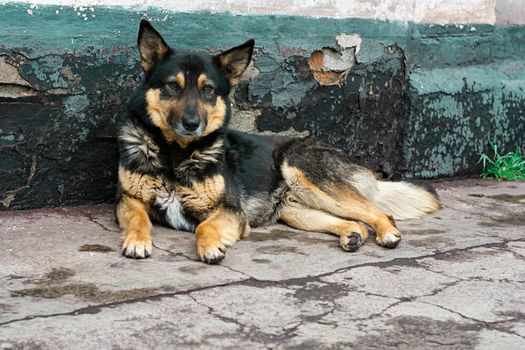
117, 196, 153, 259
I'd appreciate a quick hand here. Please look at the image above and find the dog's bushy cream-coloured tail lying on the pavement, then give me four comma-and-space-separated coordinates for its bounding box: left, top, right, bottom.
351, 173, 440, 220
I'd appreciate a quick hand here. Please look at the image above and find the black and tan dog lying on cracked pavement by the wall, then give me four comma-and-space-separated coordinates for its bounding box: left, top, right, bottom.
117, 21, 439, 263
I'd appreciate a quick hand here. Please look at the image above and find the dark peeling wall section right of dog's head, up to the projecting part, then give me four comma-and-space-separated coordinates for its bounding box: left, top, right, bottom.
245, 45, 405, 176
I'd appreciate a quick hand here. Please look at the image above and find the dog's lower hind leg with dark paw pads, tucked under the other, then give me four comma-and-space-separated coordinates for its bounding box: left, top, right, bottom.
280, 203, 368, 252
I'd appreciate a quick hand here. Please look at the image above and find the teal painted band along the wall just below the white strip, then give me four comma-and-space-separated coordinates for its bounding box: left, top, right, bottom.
0, 4, 525, 68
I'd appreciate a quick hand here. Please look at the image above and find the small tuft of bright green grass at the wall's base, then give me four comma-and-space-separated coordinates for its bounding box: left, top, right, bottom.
478, 141, 525, 180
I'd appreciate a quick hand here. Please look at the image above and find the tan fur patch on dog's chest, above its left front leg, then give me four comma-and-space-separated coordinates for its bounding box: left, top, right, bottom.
118, 168, 164, 205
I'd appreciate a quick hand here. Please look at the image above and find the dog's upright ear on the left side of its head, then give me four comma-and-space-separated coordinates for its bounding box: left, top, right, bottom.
138, 19, 170, 72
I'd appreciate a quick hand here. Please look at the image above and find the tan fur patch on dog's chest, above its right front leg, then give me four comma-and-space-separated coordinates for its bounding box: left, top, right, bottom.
177, 175, 224, 216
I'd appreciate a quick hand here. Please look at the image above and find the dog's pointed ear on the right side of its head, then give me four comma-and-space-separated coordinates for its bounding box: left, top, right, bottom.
217, 39, 255, 86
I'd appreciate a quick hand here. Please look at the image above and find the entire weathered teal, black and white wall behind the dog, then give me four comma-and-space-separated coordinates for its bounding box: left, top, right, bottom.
0, 0, 525, 209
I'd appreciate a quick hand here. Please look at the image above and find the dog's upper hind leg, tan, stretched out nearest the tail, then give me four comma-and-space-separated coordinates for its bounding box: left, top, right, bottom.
281, 161, 401, 248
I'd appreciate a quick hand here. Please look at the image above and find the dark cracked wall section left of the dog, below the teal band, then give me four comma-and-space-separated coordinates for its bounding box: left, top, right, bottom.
0, 52, 139, 209
